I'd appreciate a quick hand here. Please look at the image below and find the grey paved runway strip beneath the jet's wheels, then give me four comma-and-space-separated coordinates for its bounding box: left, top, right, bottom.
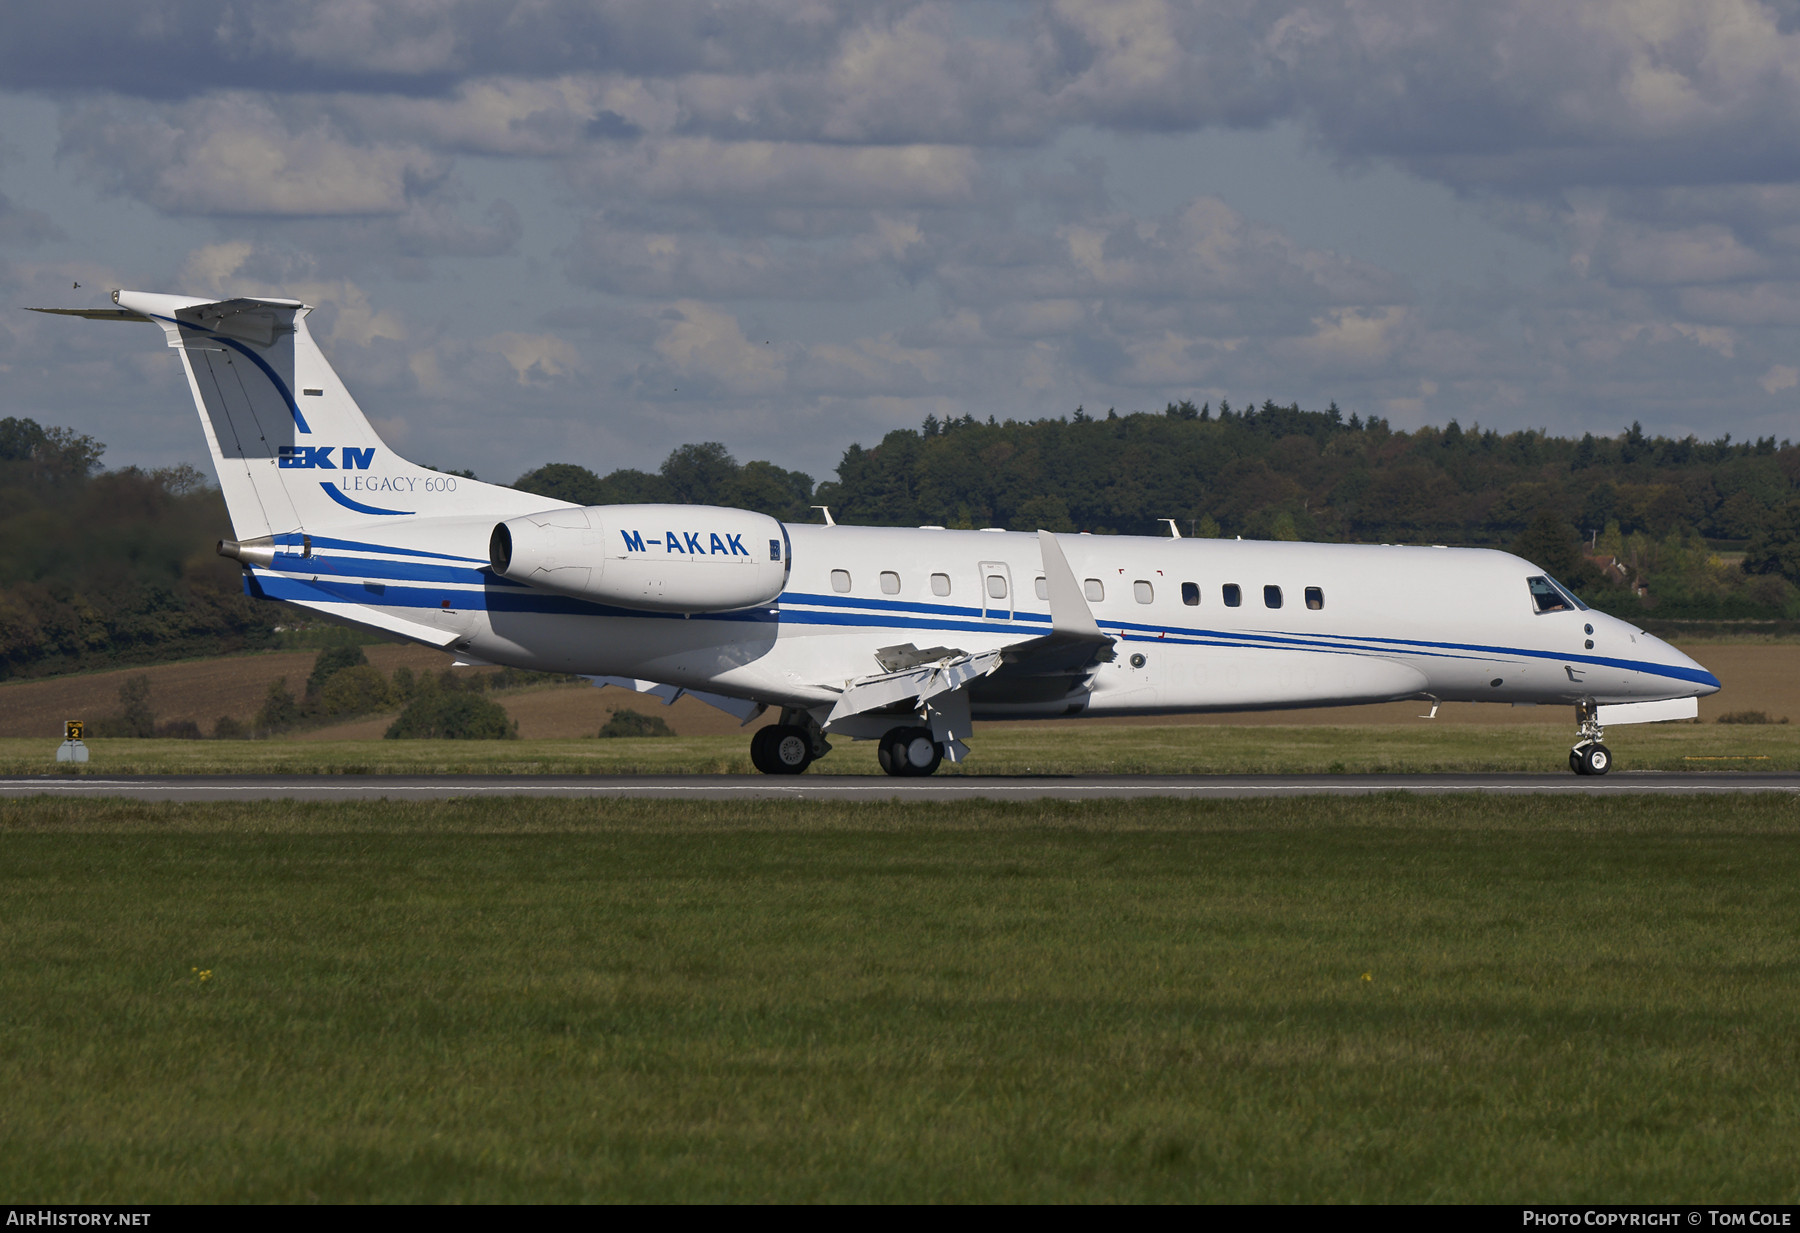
0, 770, 1800, 801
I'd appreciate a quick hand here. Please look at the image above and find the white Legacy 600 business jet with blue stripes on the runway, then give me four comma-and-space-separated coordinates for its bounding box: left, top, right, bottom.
38, 292, 1719, 776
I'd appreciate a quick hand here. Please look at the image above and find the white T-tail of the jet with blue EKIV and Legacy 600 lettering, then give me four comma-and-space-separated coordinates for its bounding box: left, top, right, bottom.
38, 292, 563, 547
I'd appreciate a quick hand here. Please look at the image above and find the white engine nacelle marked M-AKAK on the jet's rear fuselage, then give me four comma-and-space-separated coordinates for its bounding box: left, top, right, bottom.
488, 506, 788, 612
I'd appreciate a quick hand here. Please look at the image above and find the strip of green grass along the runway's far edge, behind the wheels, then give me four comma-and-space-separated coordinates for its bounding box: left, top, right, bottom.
0, 722, 1800, 774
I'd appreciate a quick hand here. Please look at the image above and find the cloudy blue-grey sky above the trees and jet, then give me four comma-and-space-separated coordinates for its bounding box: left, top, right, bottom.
0, 0, 1800, 481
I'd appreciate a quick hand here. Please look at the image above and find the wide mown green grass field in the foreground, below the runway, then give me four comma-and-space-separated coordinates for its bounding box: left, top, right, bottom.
0, 794, 1800, 1202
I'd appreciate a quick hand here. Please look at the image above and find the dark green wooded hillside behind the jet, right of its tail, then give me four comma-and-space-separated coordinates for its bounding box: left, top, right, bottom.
515, 401, 1800, 619
